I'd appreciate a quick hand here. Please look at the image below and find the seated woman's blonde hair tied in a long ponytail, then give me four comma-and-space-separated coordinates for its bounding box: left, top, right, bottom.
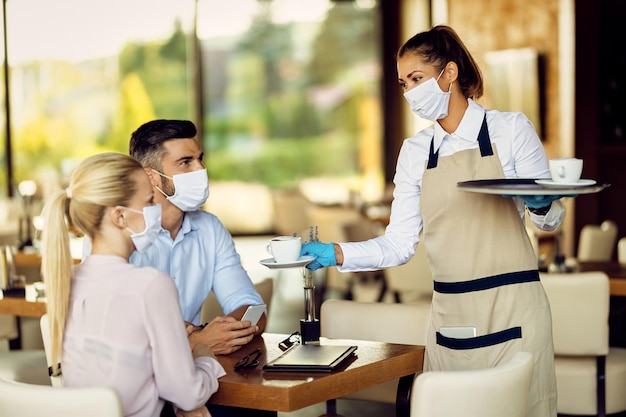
41, 152, 143, 368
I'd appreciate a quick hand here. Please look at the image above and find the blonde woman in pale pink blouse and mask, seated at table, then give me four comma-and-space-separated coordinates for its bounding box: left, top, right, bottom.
42, 153, 225, 417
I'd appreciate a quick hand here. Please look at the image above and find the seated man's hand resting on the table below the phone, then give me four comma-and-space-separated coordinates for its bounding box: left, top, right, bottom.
189, 316, 258, 355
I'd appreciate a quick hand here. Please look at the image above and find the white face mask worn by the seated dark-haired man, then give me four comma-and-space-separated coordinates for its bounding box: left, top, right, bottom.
153, 169, 209, 211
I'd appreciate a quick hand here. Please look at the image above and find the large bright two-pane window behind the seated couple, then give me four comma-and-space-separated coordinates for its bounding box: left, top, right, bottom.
0, 0, 383, 205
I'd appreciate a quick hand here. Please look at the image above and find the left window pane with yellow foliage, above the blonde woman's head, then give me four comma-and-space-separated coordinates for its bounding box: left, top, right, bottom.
7, 0, 194, 192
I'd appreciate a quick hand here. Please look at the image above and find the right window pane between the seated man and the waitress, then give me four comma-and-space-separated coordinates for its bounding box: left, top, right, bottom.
198, 0, 382, 201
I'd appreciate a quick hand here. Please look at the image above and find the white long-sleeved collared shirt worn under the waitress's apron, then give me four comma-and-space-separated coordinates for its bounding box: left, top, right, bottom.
338, 99, 565, 272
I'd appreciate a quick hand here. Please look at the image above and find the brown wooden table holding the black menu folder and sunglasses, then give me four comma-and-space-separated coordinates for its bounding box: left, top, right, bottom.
209, 333, 424, 416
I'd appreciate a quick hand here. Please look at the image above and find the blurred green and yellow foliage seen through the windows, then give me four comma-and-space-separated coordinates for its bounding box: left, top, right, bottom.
4, 3, 379, 194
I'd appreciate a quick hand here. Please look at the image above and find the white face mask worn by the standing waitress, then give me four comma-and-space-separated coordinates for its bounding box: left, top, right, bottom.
404, 68, 452, 122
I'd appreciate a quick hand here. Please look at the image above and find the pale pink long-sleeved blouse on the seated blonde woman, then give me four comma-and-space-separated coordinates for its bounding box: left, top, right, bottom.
62, 255, 225, 417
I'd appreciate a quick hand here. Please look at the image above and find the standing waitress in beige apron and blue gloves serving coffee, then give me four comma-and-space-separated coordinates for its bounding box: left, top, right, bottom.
302, 26, 565, 417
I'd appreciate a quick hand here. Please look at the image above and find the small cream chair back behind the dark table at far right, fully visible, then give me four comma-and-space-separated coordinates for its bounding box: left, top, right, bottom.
576, 220, 617, 262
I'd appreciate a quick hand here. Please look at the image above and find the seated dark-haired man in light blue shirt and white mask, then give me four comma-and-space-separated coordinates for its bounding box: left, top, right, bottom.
130, 120, 266, 354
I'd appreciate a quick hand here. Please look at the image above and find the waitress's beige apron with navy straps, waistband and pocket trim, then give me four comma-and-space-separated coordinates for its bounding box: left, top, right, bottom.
421, 119, 556, 417
